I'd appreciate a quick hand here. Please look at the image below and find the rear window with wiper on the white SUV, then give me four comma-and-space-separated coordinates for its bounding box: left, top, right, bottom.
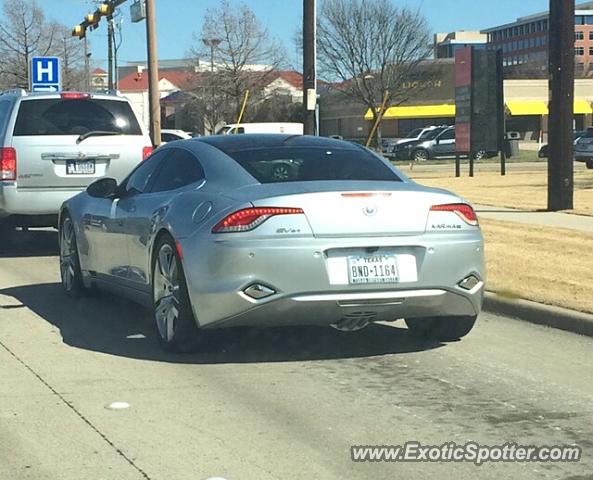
14, 98, 142, 136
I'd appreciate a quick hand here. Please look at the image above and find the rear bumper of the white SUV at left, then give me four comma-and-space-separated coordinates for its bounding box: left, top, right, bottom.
0, 182, 83, 218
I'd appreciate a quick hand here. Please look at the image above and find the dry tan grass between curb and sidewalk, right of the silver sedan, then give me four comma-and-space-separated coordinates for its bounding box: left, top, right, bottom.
481, 220, 593, 313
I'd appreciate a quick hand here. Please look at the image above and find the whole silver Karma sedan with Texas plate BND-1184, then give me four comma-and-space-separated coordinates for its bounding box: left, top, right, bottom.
59, 135, 484, 351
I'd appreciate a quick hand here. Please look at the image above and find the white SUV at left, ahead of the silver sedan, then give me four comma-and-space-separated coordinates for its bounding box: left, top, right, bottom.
0, 90, 152, 235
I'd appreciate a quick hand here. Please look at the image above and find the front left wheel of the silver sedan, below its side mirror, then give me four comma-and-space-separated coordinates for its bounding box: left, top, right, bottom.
58, 213, 88, 298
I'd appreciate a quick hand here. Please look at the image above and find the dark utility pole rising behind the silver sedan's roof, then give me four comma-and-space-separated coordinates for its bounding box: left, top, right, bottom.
303, 0, 319, 135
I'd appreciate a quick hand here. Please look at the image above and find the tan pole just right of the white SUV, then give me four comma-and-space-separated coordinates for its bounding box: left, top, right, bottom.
146, 0, 161, 147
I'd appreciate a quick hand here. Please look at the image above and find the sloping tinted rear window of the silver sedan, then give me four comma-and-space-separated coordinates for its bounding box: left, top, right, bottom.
227, 146, 401, 183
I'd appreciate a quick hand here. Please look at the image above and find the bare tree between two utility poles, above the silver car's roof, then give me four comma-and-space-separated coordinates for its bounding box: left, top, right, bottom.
191, 0, 286, 118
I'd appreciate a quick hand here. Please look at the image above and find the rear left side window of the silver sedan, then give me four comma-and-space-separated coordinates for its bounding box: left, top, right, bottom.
150, 148, 205, 193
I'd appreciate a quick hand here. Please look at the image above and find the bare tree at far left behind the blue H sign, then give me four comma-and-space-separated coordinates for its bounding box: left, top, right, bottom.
0, 0, 58, 88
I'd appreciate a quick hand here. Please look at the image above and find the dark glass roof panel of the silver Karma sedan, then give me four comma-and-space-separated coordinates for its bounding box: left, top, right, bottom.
190, 133, 362, 152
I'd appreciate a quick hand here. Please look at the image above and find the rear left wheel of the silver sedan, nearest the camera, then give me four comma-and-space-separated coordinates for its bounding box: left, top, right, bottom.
152, 235, 204, 353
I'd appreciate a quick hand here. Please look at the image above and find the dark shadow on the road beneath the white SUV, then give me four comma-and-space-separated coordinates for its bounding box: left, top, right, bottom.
0, 229, 59, 258
